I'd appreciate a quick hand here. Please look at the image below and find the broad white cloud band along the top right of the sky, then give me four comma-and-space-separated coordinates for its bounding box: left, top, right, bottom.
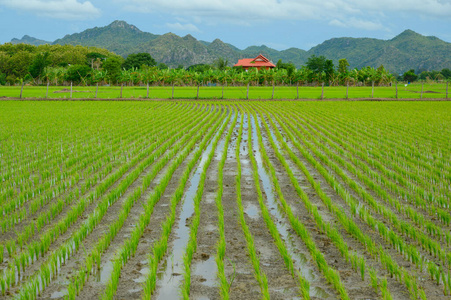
116, 0, 451, 24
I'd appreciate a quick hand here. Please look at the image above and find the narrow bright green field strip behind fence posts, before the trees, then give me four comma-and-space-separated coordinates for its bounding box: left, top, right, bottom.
0, 83, 451, 99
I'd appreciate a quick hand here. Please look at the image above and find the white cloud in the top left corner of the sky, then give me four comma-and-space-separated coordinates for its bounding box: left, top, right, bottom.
0, 0, 100, 20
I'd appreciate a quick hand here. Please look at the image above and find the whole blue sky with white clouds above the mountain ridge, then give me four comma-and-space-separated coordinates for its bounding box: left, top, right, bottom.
0, 0, 451, 50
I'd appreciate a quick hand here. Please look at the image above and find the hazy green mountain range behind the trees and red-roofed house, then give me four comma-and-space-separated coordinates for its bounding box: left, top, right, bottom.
11, 21, 451, 73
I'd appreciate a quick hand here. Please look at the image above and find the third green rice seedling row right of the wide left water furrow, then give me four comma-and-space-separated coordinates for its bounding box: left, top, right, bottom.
235, 108, 270, 299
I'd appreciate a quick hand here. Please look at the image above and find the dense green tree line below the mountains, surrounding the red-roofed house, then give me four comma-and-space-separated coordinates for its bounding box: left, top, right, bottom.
0, 43, 451, 86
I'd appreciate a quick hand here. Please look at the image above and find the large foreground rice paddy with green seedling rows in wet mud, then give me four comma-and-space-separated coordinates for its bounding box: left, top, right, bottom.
0, 101, 451, 300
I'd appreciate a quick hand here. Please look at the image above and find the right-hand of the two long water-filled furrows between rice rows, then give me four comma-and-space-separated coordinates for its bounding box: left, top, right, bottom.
251, 116, 330, 299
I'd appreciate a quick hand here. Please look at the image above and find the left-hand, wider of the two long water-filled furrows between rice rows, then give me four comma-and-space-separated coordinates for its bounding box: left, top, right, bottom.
156, 116, 230, 300
